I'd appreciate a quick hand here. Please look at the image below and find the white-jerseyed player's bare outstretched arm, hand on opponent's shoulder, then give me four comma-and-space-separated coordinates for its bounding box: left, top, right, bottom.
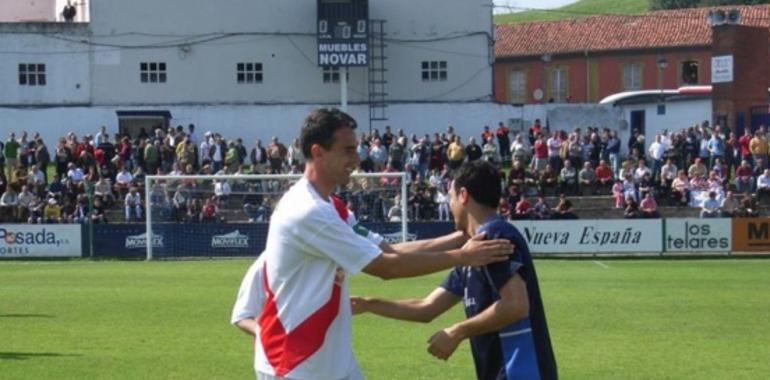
363, 234, 514, 280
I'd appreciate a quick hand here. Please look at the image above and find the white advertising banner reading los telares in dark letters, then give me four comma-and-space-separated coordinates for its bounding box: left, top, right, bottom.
663, 218, 732, 252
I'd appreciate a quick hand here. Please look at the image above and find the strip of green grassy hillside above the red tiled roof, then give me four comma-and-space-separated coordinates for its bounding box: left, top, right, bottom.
495, 0, 649, 24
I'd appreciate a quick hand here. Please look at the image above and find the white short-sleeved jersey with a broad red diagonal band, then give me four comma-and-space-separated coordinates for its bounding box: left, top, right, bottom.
232, 178, 381, 379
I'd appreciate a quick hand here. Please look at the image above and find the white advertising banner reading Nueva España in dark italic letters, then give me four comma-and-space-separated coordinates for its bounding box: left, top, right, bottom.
511, 219, 663, 253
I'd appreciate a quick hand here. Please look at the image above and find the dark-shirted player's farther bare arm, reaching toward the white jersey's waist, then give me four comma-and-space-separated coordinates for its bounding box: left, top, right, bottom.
350, 288, 460, 323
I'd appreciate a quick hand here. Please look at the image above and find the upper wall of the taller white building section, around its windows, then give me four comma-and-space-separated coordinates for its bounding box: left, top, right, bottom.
85, 0, 492, 105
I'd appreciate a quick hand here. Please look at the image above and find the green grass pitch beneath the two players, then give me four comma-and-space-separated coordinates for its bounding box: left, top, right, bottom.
0, 260, 770, 380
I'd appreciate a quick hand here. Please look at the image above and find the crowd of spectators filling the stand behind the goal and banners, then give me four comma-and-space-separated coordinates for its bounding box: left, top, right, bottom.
0, 120, 770, 223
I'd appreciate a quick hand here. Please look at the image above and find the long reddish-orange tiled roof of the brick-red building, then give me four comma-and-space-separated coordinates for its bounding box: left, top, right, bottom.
495, 5, 770, 58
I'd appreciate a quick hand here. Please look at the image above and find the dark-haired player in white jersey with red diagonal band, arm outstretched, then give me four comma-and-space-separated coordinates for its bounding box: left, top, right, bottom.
232, 109, 514, 380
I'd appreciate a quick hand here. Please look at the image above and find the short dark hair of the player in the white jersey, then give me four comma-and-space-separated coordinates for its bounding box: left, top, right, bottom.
299, 108, 357, 159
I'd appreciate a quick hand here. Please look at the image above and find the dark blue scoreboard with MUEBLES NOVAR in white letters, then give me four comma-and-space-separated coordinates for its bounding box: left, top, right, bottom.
316, 0, 369, 67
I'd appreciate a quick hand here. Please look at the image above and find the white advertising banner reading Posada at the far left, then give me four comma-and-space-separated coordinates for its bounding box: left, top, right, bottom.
0, 224, 83, 258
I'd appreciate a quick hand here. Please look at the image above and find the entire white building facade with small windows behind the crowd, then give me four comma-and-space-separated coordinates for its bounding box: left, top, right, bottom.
0, 0, 510, 145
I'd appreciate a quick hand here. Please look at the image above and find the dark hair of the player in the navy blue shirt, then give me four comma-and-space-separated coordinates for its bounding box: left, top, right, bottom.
454, 160, 502, 208
